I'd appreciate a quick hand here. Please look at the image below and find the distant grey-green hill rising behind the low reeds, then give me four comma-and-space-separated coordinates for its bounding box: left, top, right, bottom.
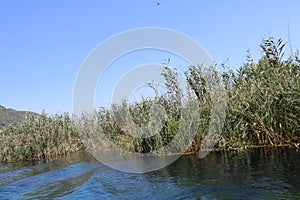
0, 105, 38, 130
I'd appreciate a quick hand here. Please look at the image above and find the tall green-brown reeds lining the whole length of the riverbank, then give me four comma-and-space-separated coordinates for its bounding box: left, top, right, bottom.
0, 37, 300, 162
